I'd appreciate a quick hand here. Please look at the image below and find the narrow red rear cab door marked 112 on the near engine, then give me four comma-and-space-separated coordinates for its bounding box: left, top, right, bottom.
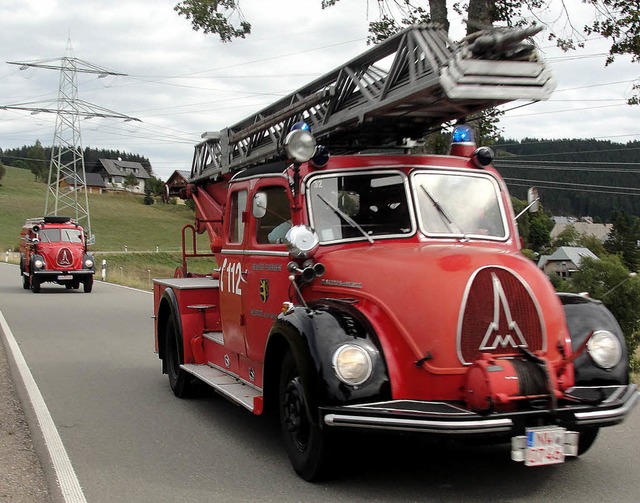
218, 183, 249, 358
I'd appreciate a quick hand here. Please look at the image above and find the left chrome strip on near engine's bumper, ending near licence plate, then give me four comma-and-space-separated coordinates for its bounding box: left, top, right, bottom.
324, 414, 513, 434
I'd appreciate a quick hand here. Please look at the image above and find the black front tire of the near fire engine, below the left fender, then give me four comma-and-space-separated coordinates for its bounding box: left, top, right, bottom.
278, 352, 330, 482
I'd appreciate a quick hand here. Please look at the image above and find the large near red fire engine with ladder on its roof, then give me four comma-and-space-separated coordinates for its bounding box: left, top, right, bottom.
154, 26, 638, 480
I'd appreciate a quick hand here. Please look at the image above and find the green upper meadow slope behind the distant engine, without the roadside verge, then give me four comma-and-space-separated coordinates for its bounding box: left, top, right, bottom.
0, 166, 206, 251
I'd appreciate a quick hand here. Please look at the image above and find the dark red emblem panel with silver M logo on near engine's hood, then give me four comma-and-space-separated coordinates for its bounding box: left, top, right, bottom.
458, 267, 545, 364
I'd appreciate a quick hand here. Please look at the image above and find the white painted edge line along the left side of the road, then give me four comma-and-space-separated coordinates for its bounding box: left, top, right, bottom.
0, 311, 87, 503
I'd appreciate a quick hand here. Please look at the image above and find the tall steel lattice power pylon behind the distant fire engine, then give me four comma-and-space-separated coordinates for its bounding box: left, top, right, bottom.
2, 40, 140, 242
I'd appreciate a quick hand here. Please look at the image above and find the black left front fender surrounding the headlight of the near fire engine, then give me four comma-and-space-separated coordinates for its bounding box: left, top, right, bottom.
265, 300, 391, 418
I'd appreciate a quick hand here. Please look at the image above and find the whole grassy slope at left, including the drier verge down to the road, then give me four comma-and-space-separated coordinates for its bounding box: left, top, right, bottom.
0, 166, 213, 289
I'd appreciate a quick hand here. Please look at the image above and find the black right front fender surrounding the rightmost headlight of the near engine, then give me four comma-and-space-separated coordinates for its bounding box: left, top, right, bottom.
558, 293, 629, 386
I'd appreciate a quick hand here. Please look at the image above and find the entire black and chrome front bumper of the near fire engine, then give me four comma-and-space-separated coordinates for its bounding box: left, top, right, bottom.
320, 384, 638, 436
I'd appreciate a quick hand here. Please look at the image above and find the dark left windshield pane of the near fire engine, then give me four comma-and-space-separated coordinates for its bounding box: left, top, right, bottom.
308, 171, 415, 243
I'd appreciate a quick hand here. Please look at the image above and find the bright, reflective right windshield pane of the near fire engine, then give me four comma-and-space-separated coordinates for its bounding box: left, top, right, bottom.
412, 172, 507, 239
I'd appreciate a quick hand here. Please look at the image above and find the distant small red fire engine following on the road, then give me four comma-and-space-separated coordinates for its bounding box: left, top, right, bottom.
20, 216, 95, 293
